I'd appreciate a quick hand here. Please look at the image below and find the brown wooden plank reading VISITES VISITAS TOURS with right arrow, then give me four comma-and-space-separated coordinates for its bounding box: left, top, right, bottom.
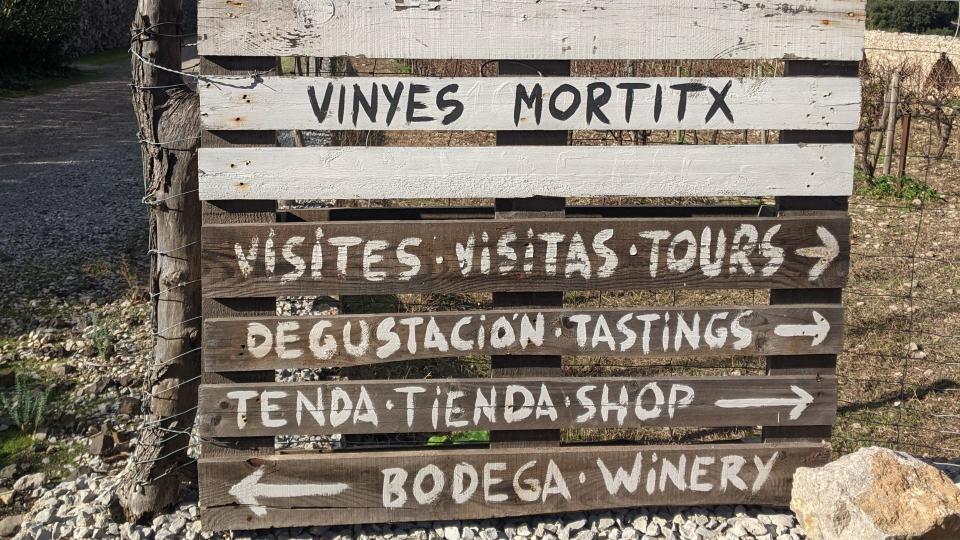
203, 216, 849, 298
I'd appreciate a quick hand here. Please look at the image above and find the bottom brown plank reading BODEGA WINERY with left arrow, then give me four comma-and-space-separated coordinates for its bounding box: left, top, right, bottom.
199, 443, 829, 530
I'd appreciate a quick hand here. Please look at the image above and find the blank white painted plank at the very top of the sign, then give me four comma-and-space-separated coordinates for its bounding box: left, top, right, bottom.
198, 0, 865, 60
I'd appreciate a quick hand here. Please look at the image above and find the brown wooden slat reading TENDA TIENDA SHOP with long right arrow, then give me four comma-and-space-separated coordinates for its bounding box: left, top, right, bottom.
199, 376, 837, 437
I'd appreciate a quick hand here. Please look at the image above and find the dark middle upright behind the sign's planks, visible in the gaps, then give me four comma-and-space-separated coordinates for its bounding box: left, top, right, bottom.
490, 60, 570, 447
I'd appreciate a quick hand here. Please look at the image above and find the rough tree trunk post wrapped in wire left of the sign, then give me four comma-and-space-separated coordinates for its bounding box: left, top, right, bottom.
118, 0, 201, 521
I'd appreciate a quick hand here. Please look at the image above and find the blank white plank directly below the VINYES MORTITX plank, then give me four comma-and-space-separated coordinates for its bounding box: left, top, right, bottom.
200, 144, 853, 200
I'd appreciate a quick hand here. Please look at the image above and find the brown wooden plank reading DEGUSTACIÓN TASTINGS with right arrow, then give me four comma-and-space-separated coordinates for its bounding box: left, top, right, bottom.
204, 305, 843, 371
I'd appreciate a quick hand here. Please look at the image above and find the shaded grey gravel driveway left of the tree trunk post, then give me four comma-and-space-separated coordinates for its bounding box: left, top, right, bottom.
0, 59, 147, 331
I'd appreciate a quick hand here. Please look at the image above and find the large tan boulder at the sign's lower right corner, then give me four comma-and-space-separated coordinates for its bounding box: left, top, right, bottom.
790, 447, 960, 540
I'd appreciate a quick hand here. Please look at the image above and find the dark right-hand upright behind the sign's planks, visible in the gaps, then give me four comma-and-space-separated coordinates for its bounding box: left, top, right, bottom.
763, 60, 859, 448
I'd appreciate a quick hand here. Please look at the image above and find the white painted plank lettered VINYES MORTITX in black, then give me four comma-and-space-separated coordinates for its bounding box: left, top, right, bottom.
199, 77, 860, 130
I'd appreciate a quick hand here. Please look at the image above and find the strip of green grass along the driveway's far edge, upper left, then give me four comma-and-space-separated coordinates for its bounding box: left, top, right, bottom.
0, 49, 130, 100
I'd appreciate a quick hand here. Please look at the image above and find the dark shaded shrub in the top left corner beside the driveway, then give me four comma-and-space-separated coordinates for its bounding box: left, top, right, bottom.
0, 0, 80, 72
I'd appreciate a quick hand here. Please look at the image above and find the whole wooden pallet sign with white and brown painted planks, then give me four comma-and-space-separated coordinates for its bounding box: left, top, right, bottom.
197, 0, 864, 531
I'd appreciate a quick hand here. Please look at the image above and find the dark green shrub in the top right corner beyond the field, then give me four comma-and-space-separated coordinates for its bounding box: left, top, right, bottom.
867, 0, 957, 35
